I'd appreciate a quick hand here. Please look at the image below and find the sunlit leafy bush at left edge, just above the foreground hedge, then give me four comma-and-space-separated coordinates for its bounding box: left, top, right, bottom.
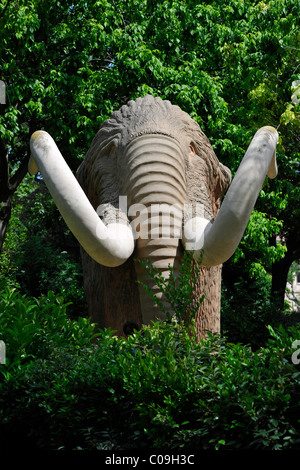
0, 282, 94, 372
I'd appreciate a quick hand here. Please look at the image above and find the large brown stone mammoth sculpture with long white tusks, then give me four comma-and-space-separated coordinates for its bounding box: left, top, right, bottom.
29, 96, 278, 338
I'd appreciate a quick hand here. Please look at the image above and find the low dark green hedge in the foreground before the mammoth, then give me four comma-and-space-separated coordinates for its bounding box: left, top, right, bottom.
0, 323, 300, 451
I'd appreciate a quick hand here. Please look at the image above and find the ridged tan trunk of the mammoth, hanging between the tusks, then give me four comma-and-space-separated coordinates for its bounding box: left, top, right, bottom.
123, 135, 186, 323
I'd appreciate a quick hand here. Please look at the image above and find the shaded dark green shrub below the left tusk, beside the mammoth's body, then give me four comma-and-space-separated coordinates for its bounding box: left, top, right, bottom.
0, 178, 87, 317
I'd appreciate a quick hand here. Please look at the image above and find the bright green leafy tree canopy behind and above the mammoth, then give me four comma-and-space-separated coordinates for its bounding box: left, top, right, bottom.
0, 0, 300, 320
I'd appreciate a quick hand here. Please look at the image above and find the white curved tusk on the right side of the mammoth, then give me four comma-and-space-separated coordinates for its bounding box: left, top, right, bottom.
183, 126, 278, 266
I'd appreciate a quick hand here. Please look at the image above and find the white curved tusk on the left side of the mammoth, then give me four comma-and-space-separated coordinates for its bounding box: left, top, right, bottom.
28, 131, 135, 267
